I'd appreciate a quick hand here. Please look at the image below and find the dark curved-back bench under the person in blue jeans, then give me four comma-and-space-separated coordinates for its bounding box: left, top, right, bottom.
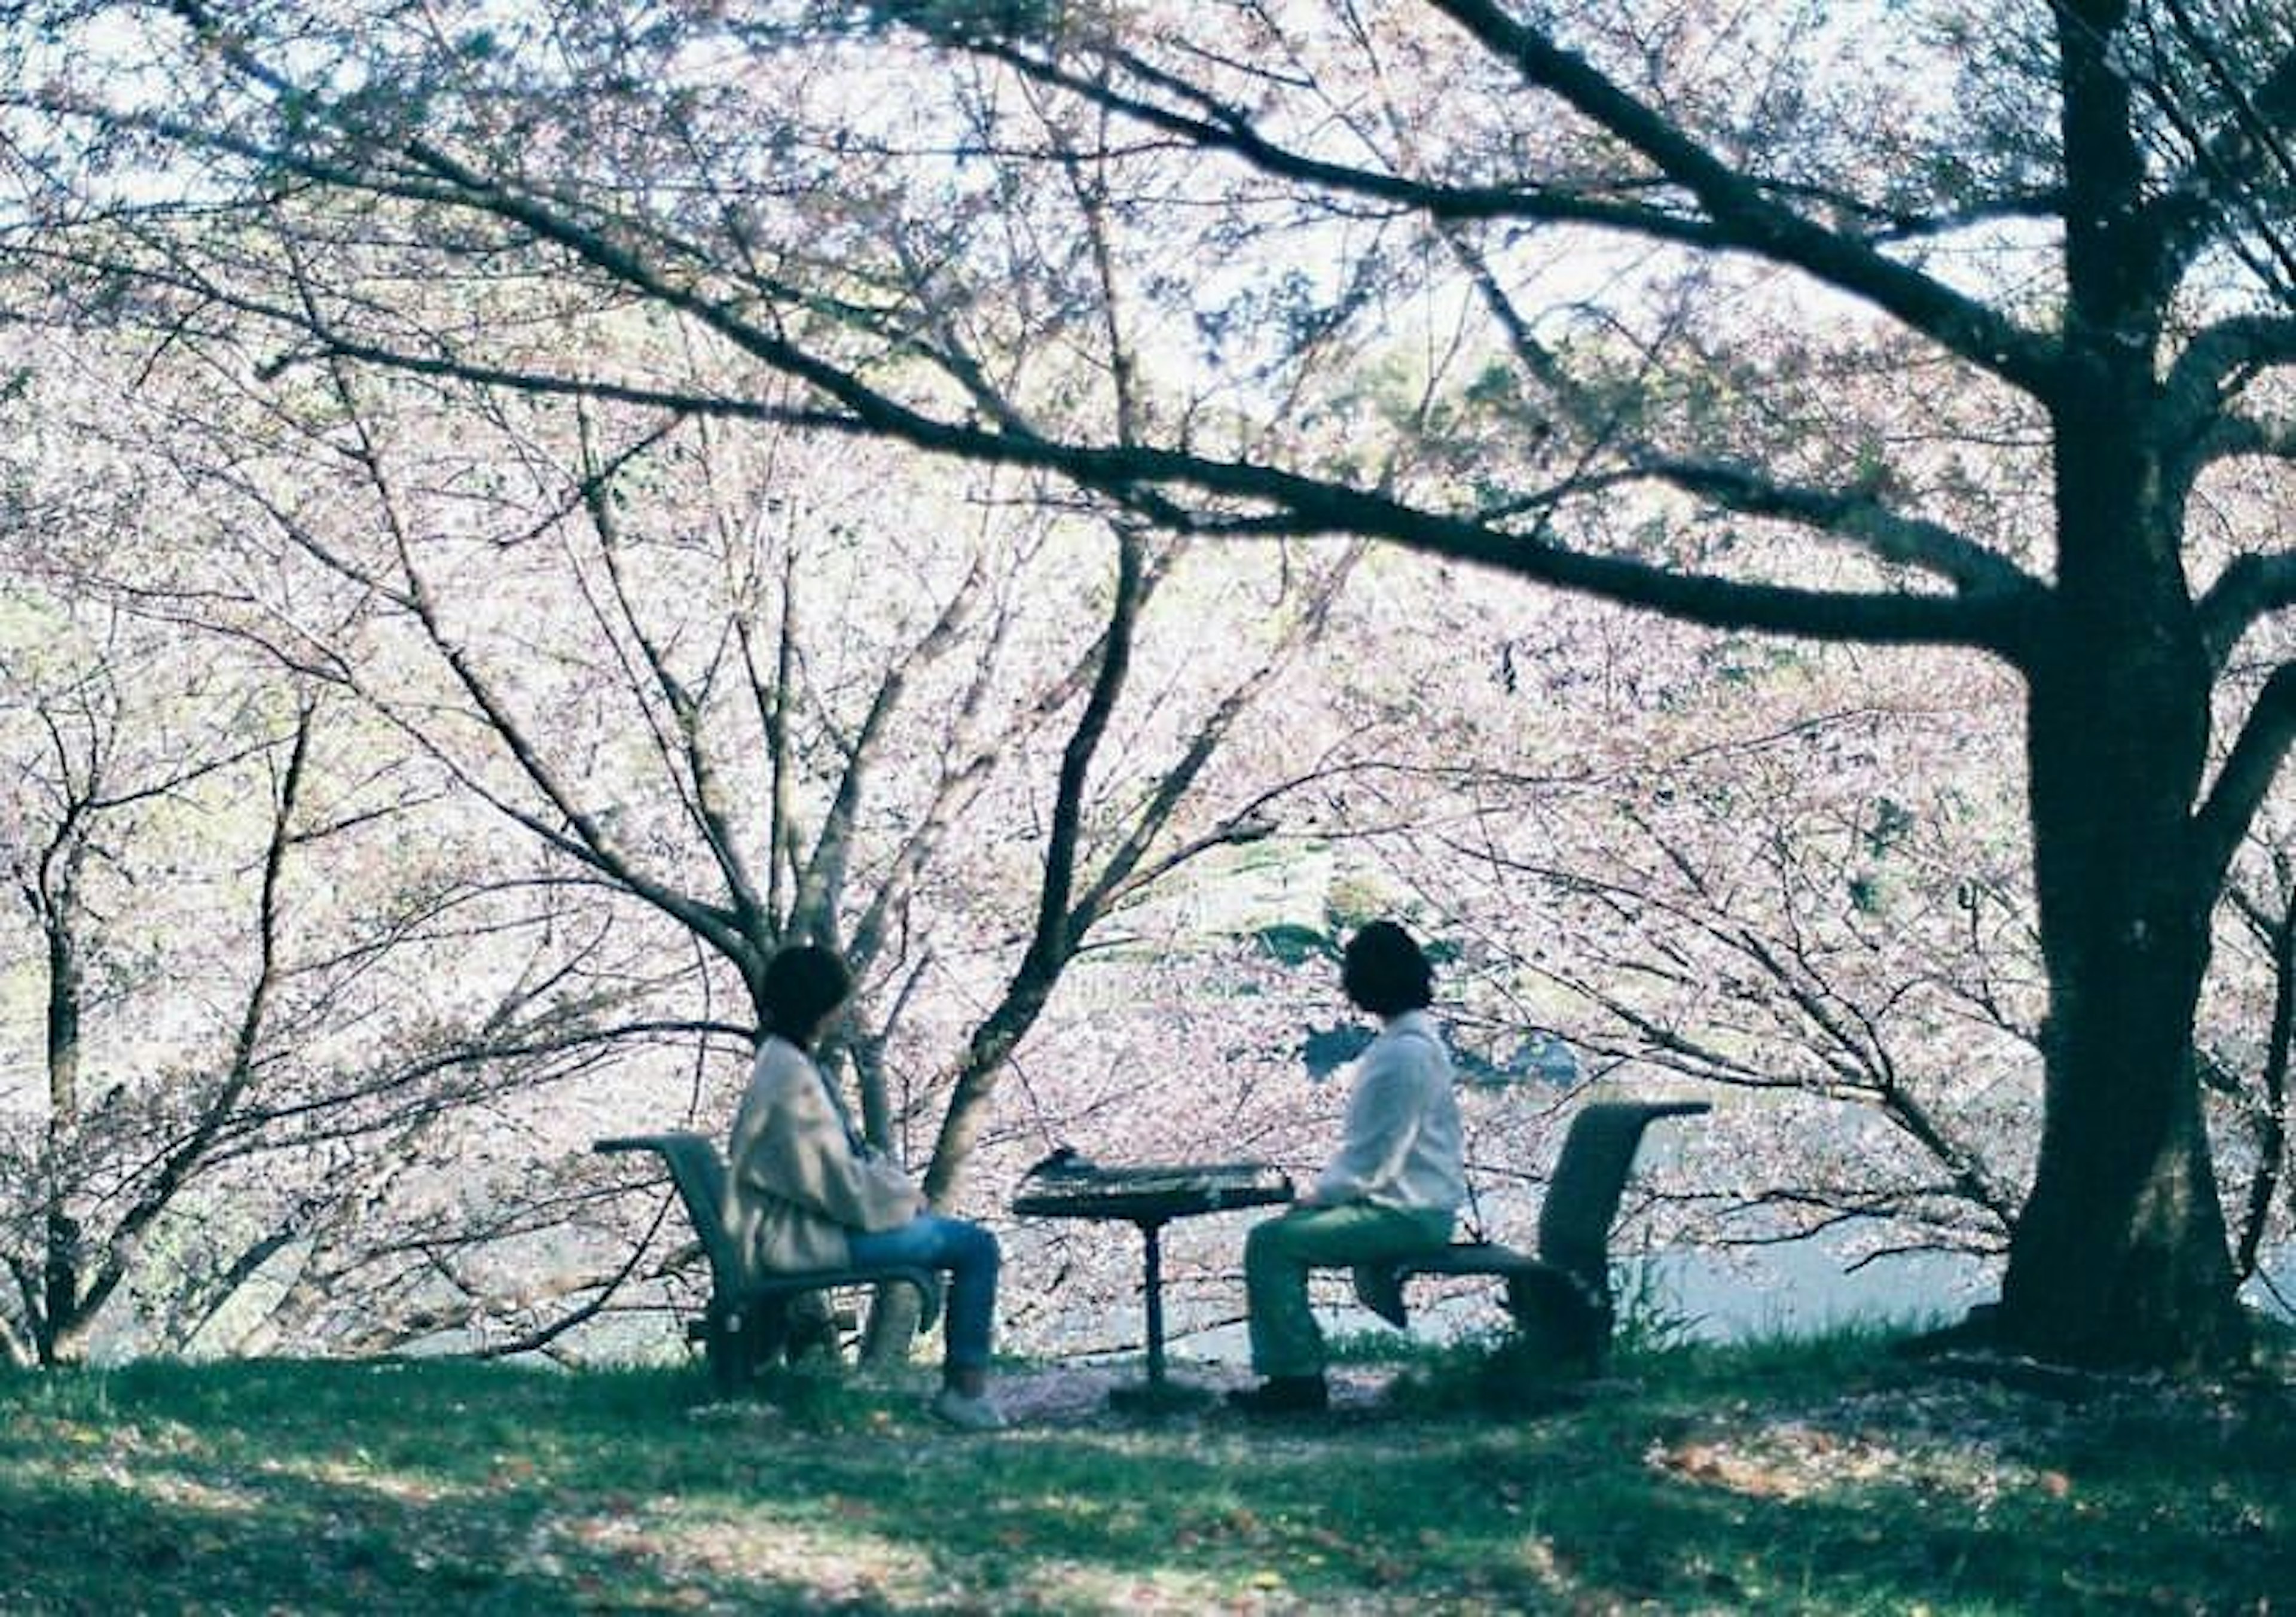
590, 1134, 941, 1392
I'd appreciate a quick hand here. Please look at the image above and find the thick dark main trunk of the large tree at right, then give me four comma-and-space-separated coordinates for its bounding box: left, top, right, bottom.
2000, 365, 2246, 1369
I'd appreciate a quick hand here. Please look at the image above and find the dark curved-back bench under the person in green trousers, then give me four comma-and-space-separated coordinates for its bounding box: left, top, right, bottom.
1355, 1100, 1713, 1374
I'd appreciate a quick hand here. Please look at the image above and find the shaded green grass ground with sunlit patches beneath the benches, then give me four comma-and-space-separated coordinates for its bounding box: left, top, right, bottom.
0, 1339, 2296, 1617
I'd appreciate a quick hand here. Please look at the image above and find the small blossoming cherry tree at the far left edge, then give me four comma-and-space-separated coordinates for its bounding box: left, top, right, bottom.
0, 581, 643, 1365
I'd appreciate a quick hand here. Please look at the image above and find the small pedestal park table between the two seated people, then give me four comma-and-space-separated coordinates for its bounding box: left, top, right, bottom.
1012, 1146, 1293, 1410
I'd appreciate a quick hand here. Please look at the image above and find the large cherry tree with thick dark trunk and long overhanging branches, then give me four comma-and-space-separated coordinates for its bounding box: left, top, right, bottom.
11, 0, 2296, 1365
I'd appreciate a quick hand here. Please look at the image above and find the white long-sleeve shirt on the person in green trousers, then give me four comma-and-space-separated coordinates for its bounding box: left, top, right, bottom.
1315, 1011, 1467, 1213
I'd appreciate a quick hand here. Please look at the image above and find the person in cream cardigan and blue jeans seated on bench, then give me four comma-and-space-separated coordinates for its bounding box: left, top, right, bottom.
725, 944, 1003, 1431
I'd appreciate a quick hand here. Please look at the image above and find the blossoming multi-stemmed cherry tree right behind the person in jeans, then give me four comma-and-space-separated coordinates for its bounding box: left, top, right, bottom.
9, 277, 1352, 1346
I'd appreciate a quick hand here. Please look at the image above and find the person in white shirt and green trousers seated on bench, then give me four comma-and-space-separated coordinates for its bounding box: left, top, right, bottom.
1228, 921, 1467, 1415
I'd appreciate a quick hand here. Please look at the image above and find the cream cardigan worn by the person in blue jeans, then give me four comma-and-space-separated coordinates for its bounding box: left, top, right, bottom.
725, 1036, 926, 1270
